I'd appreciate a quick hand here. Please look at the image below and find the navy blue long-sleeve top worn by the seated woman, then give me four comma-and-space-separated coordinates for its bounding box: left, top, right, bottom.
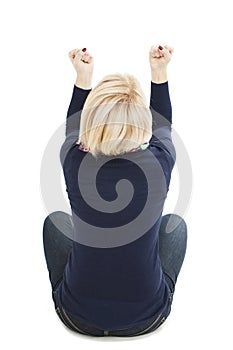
59, 82, 175, 330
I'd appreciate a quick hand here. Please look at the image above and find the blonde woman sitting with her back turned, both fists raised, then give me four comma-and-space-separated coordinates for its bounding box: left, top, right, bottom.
43, 45, 187, 337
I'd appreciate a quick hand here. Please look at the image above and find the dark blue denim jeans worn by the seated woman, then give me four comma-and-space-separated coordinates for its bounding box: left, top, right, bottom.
43, 211, 187, 337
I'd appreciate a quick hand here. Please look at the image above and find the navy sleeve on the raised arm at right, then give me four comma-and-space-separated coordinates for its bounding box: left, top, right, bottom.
150, 81, 176, 163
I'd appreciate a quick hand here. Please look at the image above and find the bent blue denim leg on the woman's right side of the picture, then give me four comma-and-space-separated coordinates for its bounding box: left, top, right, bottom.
159, 214, 187, 293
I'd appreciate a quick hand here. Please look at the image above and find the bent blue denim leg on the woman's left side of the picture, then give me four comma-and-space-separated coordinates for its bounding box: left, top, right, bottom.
43, 211, 73, 291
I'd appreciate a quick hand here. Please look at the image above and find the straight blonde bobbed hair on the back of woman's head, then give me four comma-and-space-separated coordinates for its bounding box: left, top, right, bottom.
76, 73, 152, 157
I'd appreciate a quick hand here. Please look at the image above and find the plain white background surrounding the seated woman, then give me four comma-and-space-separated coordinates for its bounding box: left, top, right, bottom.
0, 0, 233, 350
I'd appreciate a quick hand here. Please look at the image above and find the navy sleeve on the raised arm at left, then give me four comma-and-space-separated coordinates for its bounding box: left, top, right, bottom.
60, 85, 91, 166
